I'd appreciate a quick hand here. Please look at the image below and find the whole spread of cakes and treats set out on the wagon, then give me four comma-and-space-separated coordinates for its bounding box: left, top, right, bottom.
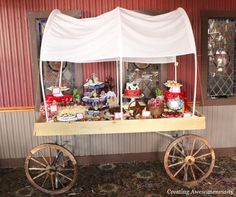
40, 73, 190, 122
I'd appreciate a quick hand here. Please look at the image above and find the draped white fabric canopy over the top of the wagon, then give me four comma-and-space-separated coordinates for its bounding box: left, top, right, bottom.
40, 7, 196, 63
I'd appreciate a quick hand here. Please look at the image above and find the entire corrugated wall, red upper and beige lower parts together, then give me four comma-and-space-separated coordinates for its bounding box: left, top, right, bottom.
0, 0, 236, 158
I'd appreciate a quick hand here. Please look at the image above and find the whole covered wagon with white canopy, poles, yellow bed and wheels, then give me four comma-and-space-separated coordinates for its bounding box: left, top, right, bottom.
25, 7, 215, 195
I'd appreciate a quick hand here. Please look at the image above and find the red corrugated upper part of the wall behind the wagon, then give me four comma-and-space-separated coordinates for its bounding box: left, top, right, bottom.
0, 0, 236, 108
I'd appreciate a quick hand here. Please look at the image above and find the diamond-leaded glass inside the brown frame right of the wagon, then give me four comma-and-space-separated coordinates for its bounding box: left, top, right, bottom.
207, 19, 236, 99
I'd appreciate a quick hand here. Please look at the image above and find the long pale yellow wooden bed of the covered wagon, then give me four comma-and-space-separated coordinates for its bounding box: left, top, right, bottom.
33, 112, 205, 136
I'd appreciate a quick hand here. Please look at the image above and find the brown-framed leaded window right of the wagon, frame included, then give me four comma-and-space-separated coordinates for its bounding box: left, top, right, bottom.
201, 11, 236, 105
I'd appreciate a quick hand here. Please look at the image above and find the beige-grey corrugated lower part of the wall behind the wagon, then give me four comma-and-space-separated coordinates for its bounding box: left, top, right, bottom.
0, 106, 236, 159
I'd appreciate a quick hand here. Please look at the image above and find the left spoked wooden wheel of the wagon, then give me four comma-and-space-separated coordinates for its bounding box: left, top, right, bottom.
25, 144, 78, 195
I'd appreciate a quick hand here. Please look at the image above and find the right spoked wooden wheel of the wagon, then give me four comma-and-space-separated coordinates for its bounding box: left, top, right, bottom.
164, 135, 215, 187
